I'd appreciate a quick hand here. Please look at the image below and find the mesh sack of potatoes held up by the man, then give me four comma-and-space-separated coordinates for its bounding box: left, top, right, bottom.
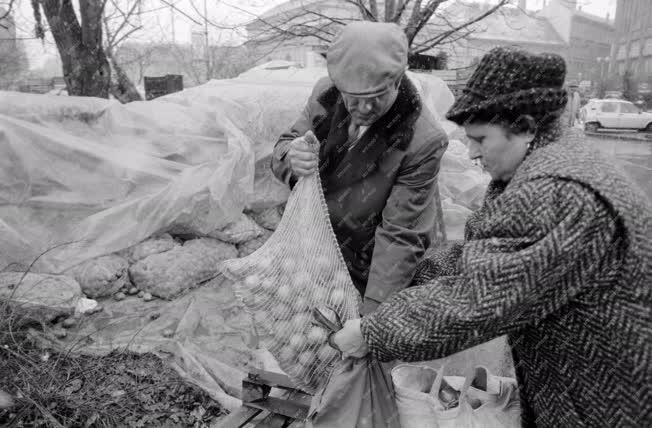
221, 149, 360, 393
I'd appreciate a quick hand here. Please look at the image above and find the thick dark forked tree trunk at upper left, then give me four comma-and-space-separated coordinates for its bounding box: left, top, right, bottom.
41, 0, 111, 98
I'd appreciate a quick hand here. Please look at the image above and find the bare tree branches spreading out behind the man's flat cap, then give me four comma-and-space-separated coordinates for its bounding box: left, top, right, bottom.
242, 0, 512, 54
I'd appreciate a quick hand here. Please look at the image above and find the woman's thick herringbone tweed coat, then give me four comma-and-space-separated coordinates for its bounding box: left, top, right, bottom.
362, 129, 652, 428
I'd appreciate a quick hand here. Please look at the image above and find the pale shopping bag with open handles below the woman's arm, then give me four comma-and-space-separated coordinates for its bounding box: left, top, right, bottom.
392, 364, 520, 428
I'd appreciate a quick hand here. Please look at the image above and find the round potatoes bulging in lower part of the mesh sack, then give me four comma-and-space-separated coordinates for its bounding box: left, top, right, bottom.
232, 257, 350, 392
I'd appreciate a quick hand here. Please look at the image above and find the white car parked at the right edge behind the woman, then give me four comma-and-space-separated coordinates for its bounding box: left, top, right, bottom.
580, 99, 652, 132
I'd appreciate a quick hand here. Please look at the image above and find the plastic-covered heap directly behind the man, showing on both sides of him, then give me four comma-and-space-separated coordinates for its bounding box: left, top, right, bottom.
165, 65, 489, 231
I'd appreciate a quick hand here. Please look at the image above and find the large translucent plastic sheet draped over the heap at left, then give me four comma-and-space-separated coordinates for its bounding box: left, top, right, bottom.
0, 92, 254, 273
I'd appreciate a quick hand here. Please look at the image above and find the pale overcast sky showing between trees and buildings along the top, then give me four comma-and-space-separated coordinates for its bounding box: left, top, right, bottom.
5, 0, 616, 69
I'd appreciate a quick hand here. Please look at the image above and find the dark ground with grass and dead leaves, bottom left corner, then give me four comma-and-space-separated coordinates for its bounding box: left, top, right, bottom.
0, 304, 222, 427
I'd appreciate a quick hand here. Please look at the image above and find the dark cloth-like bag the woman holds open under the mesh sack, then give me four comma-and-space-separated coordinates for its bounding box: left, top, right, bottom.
306, 357, 401, 428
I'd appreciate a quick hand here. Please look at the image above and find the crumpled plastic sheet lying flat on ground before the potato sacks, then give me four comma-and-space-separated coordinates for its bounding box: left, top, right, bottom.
35, 276, 255, 410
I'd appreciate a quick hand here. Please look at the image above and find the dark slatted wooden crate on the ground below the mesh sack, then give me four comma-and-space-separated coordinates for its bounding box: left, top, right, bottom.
212, 370, 312, 428
